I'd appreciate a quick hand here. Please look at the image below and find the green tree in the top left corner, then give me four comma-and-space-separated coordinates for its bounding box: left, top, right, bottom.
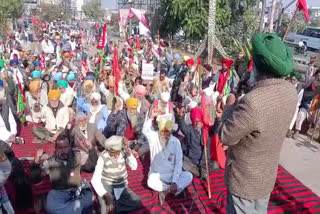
0, 0, 23, 35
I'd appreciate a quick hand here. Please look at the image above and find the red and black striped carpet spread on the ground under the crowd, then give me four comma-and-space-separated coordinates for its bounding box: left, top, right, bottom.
13, 127, 320, 214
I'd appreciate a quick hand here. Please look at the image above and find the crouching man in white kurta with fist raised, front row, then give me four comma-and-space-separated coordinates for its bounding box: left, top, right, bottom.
142, 109, 192, 205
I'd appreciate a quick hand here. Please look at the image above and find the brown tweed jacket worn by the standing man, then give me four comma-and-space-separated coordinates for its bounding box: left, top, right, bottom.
220, 79, 297, 200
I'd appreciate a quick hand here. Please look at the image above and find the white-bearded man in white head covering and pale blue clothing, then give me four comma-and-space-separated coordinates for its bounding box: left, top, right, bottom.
88, 92, 109, 131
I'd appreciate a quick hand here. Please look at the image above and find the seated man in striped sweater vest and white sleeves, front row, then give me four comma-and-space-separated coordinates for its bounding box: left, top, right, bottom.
91, 135, 141, 214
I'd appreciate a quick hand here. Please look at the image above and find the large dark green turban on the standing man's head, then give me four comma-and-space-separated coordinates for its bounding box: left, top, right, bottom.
252, 33, 293, 77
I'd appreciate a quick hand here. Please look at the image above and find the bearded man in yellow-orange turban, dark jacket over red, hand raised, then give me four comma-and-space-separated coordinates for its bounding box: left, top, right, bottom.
104, 98, 149, 157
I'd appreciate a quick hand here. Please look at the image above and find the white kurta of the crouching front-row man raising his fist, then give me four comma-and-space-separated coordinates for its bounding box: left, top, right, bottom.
142, 118, 192, 194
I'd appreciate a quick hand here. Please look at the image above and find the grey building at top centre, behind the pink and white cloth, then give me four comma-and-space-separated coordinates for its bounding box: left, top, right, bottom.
117, 0, 160, 14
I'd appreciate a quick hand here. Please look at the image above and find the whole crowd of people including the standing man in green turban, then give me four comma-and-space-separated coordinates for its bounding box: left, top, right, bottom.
0, 20, 320, 214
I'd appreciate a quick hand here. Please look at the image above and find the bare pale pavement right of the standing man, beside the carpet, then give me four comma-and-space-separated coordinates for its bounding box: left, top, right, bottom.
280, 135, 320, 196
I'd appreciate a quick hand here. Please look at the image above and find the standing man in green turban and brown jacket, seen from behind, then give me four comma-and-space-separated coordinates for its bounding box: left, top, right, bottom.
214, 34, 297, 214
